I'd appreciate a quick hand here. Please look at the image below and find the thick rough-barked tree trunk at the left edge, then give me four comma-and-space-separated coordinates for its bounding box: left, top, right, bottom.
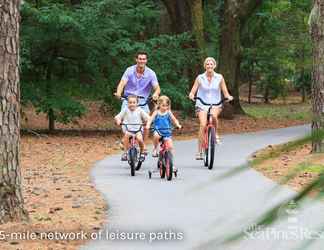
0, 0, 28, 224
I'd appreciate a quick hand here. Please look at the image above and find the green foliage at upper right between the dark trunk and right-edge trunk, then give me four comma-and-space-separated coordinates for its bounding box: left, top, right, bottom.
242, 0, 311, 101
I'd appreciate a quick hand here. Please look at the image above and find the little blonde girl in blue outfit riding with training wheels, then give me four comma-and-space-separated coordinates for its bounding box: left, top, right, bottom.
146, 96, 181, 157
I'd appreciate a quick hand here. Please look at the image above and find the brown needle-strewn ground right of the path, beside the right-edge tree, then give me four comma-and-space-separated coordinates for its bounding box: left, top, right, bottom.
251, 142, 324, 197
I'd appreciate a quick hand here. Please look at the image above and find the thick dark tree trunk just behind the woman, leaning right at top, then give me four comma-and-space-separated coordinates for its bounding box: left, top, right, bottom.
219, 0, 262, 113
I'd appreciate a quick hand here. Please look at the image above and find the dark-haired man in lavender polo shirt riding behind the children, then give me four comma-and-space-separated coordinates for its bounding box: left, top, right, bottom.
115, 52, 161, 153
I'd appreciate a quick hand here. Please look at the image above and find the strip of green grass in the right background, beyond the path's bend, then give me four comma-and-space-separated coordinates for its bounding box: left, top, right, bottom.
243, 103, 311, 121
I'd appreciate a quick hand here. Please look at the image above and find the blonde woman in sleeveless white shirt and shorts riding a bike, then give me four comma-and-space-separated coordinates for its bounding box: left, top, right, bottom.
189, 57, 233, 160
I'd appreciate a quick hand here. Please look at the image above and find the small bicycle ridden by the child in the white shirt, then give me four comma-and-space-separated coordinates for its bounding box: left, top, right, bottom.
120, 123, 145, 176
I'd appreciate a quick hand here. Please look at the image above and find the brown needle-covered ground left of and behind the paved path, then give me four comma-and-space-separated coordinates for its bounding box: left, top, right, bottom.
0, 96, 310, 250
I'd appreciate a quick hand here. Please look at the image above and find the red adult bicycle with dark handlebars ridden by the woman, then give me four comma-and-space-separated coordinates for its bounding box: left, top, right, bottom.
194, 97, 228, 169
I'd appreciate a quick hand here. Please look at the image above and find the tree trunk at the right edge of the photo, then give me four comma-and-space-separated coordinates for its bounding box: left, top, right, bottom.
309, 0, 324, 153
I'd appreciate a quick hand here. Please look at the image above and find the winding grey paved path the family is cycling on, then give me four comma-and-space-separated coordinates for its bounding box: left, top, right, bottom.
81, 126, 324, 250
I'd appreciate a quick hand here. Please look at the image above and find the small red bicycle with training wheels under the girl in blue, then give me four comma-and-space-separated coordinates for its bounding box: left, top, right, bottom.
148, 128, 178, 181
